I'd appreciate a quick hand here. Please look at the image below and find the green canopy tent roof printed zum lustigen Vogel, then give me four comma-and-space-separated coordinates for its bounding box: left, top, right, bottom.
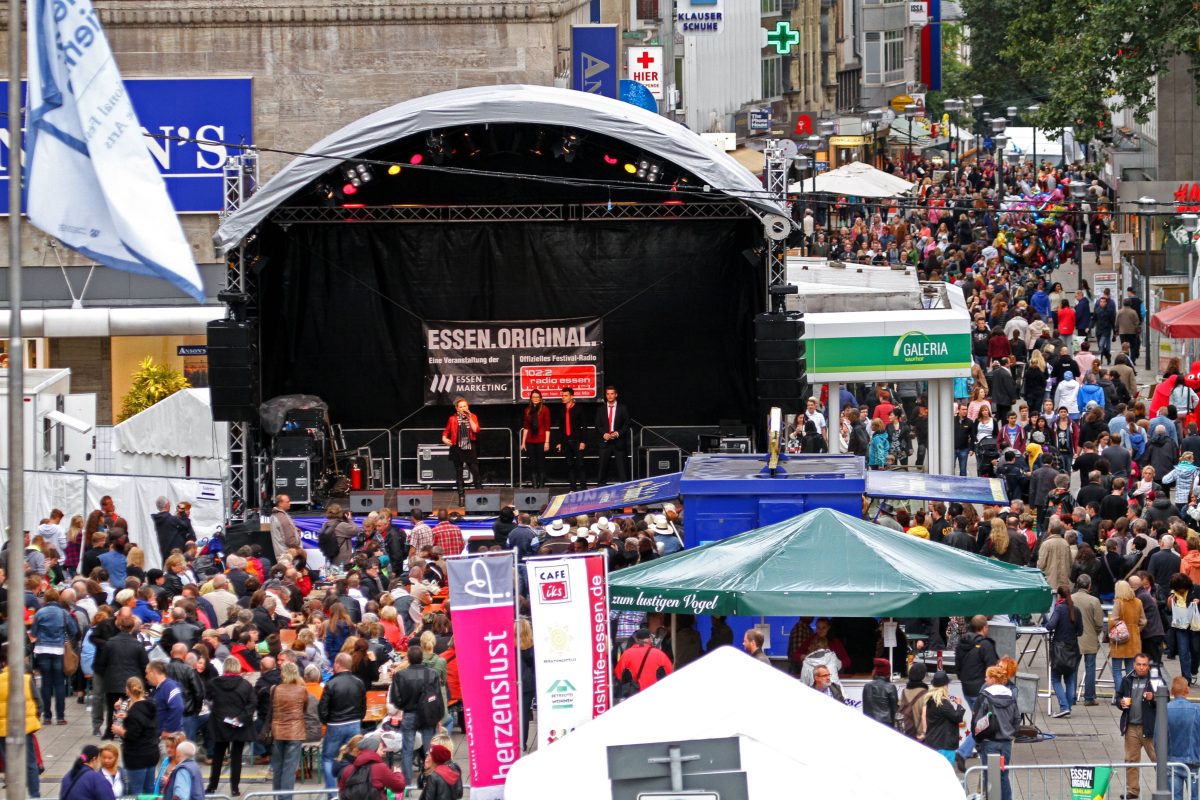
610, 509, 1051, 618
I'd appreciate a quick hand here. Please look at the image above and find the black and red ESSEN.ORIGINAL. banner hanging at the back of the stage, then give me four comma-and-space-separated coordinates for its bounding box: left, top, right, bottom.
422, 318, 604, 405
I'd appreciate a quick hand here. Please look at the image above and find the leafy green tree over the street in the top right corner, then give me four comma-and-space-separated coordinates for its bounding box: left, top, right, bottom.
988, 0, 1200, 142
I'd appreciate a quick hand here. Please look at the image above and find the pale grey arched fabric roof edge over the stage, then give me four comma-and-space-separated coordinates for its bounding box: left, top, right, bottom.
214, 85, 786, 253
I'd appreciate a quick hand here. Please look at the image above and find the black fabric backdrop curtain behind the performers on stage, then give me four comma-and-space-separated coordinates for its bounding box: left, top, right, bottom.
258, 219, 763, 428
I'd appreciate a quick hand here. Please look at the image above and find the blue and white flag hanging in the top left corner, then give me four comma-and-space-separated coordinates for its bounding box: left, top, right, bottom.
25, 0, 204, 302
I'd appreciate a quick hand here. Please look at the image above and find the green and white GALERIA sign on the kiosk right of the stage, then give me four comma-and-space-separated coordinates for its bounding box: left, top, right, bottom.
806, 331, 971, 378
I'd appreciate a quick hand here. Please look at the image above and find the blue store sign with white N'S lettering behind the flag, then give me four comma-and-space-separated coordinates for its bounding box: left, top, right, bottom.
0, 78, 254, 213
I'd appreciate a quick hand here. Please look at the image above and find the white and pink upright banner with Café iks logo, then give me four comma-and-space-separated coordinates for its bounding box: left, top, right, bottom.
530, 553, 612, 748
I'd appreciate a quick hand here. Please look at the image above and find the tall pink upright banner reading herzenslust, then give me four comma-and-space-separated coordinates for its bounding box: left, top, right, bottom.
446, 553, 521, 800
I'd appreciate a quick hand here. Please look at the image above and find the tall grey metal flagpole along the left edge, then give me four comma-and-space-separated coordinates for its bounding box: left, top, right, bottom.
5, 0, 32, 800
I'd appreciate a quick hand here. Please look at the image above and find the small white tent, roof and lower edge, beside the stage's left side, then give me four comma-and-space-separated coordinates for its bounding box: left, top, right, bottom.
113, 389, 229, 479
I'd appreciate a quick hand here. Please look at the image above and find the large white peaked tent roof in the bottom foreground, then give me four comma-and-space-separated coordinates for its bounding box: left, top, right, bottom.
504, 648, 962, 800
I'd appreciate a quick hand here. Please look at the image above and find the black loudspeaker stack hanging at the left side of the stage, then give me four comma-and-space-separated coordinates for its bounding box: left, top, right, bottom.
209, 319, 258, 422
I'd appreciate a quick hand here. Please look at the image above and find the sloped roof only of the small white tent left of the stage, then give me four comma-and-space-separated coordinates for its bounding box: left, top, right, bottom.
113, 389, 226, 458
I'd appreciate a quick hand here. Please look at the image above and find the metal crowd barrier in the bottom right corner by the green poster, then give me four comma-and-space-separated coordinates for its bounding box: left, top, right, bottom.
962, 762, 1198, 800
